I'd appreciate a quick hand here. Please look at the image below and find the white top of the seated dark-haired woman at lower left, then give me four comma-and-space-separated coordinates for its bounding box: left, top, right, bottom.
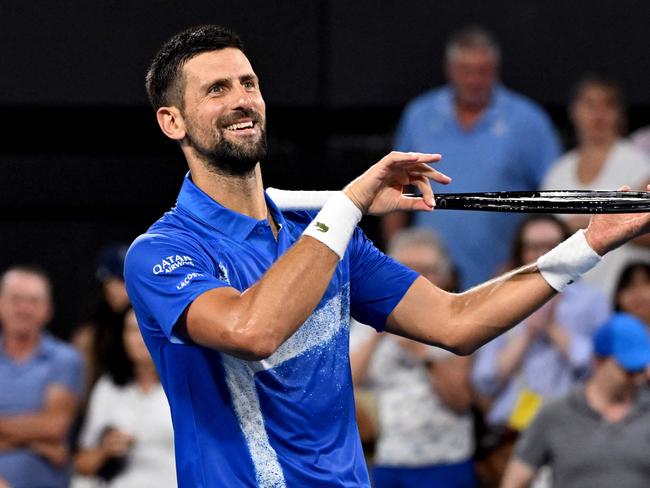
72, 376, 177, 488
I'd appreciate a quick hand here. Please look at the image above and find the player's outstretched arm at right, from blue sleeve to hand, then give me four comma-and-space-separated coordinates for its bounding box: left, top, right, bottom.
386, 206, 650, 355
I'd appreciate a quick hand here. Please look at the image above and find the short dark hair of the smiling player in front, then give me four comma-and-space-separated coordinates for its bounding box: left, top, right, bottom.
145, 25, 244, 110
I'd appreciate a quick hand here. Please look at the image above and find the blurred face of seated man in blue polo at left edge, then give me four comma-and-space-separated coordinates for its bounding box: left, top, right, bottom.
0, 271, 51, 337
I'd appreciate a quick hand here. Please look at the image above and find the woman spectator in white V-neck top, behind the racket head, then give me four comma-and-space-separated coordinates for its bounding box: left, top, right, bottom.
542, 76, 650, 297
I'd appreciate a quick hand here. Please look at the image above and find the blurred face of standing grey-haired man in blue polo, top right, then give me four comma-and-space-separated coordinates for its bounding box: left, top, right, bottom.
446, 48, 498, 107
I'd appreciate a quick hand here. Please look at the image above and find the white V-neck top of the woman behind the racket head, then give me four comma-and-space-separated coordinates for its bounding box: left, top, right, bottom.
542, 139, 650, 297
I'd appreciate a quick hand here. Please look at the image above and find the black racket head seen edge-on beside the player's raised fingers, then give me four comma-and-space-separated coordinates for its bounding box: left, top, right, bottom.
435, 190, 650, 214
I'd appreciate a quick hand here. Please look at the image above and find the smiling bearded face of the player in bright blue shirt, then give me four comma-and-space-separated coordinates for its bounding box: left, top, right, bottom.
177, 48, 266, 176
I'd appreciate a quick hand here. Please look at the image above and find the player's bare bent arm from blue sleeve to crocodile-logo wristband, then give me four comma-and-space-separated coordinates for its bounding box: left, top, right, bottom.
181, 236, 339, 360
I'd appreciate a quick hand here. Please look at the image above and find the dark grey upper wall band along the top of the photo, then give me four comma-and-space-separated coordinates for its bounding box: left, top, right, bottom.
0, 0, 650, 107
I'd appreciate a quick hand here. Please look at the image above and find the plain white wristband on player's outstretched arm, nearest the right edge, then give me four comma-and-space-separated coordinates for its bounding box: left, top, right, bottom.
537, 229, 603, 291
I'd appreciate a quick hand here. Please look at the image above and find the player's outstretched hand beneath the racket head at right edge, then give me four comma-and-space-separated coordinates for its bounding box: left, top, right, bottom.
585, 185, 650, 256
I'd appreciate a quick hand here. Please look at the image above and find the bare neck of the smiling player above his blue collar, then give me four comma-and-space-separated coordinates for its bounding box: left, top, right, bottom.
188, 158, 268, 220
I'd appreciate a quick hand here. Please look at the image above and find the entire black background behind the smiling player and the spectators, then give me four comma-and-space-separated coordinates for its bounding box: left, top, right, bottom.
0, 0, 650, 333
